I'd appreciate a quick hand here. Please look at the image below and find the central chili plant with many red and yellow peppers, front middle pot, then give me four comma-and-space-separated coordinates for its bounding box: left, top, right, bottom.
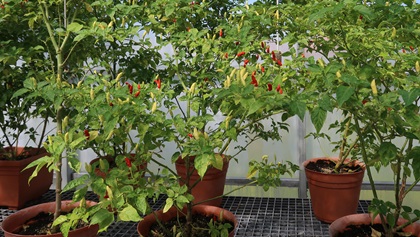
79, 1, 306, 236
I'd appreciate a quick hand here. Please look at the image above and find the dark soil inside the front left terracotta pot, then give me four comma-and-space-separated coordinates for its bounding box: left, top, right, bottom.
13, 212, 87, 235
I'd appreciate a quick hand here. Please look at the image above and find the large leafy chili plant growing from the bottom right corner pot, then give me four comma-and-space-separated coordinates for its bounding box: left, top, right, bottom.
288, 1, 420, 236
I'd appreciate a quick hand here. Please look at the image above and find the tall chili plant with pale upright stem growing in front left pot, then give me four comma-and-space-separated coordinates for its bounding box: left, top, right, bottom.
1, 1, 153, 236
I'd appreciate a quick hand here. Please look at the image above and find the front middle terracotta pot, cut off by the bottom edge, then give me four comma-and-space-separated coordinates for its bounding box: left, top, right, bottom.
137, 205, 238, 237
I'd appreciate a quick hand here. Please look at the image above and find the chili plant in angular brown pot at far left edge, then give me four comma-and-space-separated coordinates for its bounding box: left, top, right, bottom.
0, 0, 52, 209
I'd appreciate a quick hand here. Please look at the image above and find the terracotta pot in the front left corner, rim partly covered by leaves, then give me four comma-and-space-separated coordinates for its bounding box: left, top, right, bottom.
1, 201, 99, 237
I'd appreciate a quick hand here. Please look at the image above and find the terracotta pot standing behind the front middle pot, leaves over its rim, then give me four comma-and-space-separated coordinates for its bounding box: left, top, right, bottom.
175, 155, 229, 206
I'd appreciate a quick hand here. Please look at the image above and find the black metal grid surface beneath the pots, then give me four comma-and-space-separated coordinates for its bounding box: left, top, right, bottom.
0, 190, 369, 237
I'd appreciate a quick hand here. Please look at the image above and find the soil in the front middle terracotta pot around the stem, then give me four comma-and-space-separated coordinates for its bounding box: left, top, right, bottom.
149, 214, 234, 237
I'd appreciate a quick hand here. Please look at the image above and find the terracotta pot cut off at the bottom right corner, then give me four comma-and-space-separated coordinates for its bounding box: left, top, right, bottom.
329, 213, 420, 237
